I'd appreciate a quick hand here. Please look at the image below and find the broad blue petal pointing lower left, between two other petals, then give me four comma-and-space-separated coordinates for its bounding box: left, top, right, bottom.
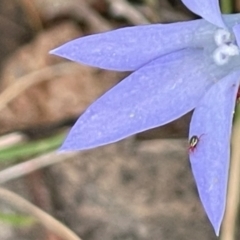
60, 49, 216, 150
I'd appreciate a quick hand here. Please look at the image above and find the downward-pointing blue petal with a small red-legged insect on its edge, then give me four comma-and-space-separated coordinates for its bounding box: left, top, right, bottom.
190, 71, 240, 235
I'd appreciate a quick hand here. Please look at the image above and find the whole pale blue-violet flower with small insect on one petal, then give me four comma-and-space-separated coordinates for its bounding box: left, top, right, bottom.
51, 0, 240, 235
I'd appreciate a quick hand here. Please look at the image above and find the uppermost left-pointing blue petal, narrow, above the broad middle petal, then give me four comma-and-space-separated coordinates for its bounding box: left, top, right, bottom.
50, 19, 214, 71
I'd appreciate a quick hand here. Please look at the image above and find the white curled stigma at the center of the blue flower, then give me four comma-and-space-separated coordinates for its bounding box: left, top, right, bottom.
213, 29, 240, 66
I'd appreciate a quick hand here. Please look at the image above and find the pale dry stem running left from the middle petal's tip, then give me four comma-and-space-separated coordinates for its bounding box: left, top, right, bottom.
0, 151, 78, 184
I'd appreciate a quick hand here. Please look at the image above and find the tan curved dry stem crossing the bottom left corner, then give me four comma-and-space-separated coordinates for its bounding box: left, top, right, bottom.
0, 188, 81, 240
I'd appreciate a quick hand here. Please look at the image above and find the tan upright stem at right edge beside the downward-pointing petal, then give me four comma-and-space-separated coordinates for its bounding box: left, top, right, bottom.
220, 103, 240, 240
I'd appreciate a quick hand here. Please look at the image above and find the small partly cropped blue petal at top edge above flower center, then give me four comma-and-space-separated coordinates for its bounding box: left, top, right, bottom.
182, 0, 226, 28
